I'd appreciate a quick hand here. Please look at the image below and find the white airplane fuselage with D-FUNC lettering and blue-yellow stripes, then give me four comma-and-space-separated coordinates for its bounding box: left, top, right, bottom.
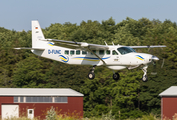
32, 42, 152, 70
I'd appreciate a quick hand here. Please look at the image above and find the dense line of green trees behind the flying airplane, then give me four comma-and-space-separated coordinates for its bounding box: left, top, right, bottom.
0, 17, 177, 119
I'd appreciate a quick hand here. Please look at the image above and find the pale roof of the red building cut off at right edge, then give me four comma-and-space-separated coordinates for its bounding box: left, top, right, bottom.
159, 86, 177, 97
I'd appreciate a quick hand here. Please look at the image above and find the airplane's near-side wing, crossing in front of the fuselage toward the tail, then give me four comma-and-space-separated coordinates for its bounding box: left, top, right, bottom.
40, 39, 109, 50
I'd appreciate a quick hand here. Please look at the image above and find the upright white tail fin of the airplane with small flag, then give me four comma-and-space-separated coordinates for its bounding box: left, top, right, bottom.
31, 21, 46, 48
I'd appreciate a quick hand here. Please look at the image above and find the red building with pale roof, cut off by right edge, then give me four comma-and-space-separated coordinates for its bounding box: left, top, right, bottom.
159, 86, 177, 119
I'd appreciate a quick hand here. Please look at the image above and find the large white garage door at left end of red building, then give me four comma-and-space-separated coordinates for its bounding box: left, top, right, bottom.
1, 105, 19, 119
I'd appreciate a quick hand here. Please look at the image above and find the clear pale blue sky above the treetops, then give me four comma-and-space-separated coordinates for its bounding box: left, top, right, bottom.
0, 0, 177, 31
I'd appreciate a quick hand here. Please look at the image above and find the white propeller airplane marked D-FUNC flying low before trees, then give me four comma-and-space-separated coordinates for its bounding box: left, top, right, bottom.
15, 20, 166, 82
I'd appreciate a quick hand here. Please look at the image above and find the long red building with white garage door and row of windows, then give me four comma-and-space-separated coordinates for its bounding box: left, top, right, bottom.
0, 88, 84, 119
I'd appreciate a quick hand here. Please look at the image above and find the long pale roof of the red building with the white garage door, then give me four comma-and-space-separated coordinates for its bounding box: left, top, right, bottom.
0, 88, 84, 96
